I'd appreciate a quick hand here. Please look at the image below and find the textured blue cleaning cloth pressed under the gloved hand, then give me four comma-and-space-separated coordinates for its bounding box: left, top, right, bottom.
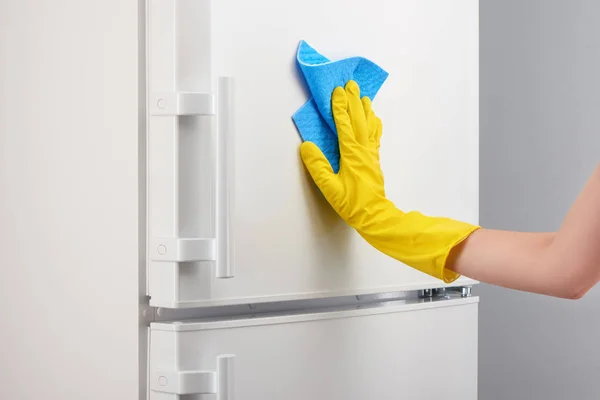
292, 41, 388, 173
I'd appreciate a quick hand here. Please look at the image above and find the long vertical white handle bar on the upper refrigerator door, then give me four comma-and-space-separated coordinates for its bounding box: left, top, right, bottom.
215, 77, 235, 279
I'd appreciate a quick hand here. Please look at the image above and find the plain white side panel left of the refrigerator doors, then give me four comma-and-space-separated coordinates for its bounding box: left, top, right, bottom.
0, 0, 146, 400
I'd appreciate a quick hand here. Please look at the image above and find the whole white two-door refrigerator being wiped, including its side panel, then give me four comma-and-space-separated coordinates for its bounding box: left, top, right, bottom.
0, 0, 479, 400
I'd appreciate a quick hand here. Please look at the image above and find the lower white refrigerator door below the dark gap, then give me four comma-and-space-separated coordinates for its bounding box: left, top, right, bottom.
148, 298, 477, 400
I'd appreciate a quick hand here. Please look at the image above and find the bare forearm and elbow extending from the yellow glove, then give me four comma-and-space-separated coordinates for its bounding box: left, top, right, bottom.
448, 164, 600, 298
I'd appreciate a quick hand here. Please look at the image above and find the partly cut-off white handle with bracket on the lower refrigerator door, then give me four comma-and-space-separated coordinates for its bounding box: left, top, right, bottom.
150, 354, 235, 400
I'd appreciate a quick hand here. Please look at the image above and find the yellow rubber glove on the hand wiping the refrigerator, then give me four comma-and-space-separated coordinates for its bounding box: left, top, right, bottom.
300, 81, 479, 283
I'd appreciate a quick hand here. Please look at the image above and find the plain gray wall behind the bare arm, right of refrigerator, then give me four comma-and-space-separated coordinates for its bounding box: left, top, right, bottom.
478, 0, 600, 400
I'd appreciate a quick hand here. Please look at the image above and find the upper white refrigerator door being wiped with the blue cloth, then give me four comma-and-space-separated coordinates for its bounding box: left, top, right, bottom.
147, 0, 478, 308
